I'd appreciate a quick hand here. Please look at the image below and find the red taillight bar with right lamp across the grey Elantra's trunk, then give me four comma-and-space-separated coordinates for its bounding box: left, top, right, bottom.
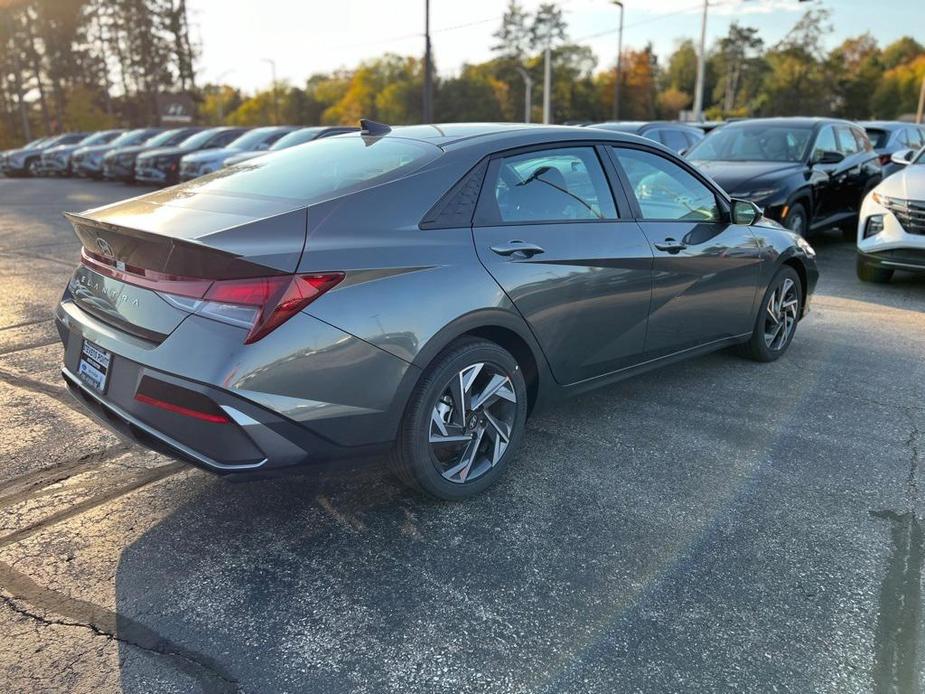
81, 249, 344, 345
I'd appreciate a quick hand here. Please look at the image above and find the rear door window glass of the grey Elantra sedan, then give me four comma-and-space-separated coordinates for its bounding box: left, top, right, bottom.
491, 147, 617, 224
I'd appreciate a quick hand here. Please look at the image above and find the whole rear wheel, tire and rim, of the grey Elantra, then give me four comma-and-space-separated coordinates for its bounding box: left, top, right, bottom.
390, 338, 527, 500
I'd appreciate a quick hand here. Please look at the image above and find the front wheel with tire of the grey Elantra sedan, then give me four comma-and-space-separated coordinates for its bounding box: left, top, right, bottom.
740, 265, 803, 362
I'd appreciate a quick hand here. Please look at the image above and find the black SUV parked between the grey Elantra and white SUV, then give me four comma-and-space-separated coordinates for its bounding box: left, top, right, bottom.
686, 118, 883, 238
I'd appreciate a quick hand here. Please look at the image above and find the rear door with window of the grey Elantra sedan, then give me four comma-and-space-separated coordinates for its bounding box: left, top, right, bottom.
473, 145, 652, 384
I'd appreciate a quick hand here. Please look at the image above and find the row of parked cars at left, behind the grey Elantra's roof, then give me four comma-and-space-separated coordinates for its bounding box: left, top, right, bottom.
0, 125, 356, 185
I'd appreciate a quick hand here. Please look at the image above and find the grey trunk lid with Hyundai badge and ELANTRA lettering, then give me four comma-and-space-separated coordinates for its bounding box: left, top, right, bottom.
65, 190, 307, 342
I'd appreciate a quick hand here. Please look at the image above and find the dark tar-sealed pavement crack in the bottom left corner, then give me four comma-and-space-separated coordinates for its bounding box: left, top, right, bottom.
0, 563, 241, 694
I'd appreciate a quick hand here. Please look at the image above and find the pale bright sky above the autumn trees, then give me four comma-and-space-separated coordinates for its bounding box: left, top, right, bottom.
187, 0, 923, 92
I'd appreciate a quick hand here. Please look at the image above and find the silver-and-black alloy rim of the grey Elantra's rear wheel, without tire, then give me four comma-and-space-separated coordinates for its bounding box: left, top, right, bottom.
429, 362, 517, 484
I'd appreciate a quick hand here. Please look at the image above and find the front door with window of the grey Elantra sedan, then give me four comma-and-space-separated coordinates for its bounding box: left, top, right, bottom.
611, 145, 762, 359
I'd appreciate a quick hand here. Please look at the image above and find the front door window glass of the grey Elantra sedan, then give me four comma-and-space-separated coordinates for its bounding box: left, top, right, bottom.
614, 147, 720, 222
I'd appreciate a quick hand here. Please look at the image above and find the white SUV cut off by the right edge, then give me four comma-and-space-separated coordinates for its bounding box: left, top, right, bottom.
857, 147, 925, 282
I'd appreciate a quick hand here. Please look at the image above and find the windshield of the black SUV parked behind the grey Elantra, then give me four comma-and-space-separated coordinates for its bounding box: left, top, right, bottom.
686, 124, 813, 162
